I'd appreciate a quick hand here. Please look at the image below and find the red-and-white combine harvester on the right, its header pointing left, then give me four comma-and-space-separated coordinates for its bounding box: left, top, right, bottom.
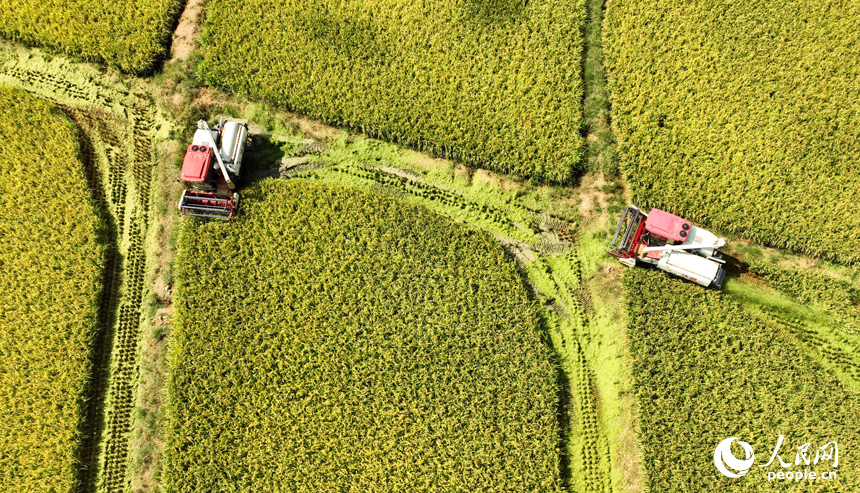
606, 205, 726, 289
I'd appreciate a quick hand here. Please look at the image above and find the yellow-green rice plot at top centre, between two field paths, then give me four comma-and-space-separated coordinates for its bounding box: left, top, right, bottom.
201, 0, 584, 182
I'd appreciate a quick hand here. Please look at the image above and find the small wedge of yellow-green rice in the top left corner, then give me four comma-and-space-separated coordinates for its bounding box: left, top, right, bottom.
0, 0, 184, 73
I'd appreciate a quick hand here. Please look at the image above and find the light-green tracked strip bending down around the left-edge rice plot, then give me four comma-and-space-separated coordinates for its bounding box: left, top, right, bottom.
0, 52, 153, 493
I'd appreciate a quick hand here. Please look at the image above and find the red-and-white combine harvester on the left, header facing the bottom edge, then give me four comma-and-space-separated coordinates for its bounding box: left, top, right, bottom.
179, 118, 249, 220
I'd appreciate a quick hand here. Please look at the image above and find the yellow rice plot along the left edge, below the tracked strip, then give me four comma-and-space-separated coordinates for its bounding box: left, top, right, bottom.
0, 86, 103, 492
